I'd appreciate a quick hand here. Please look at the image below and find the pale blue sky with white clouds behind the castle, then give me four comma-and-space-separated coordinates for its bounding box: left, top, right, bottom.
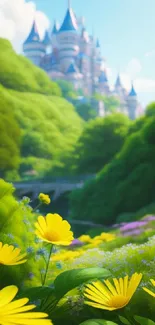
0, 0, 155, 106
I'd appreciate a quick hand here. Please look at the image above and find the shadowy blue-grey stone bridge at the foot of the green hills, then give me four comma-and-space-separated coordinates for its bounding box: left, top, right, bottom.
13, 175, 94, 201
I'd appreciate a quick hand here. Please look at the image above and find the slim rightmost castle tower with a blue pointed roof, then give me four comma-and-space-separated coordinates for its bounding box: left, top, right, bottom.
127, 84, 138, 120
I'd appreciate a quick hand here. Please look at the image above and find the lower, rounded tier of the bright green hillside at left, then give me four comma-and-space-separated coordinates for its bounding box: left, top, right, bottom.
0, 83, 83, 174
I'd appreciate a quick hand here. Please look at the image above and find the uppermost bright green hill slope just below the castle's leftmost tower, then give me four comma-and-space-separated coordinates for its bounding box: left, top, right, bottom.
0, 38, 61, 96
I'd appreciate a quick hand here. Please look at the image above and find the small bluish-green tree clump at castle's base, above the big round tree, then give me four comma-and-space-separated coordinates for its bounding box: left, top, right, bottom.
76, 104, 97, 121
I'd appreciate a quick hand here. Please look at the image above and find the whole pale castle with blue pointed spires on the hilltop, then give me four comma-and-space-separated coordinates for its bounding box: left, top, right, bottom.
23, 1, 142, 120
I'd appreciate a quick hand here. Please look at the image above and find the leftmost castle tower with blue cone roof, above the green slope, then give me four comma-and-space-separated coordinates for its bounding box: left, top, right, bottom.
23, 21, 45, 66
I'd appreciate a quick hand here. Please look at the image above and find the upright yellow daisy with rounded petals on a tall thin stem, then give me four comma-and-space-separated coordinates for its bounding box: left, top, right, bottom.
35, 213, 74, 246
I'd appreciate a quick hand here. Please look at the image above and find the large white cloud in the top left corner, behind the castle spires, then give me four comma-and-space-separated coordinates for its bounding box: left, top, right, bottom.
0, 0, 50, 52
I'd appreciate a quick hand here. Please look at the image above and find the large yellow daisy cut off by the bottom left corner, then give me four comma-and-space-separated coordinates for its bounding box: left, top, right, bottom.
0, 285, 52, 325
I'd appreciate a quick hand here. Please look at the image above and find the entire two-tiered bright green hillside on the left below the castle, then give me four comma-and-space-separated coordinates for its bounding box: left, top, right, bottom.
0, 39, 83, 175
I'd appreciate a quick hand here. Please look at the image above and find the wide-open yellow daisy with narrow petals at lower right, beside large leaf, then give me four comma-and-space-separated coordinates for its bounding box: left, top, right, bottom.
84, 273, 142, 310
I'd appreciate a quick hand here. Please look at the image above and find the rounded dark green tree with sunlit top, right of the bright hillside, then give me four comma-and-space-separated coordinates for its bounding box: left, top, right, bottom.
75, 113, 130, 173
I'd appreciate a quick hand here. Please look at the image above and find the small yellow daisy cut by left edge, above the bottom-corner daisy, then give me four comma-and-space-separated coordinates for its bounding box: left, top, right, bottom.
0, 242, 27, 265
